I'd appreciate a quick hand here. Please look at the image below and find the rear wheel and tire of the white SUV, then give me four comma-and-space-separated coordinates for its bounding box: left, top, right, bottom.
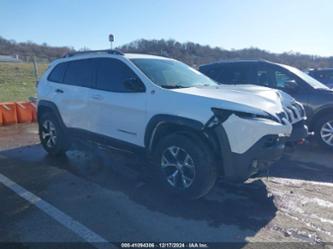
39, 113, 69, 156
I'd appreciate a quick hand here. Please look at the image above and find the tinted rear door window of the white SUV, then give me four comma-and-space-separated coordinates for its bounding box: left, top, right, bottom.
64, 59, 94, 87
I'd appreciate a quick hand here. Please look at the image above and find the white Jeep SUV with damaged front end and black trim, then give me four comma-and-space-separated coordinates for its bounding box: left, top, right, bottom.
38, 50, 307, 198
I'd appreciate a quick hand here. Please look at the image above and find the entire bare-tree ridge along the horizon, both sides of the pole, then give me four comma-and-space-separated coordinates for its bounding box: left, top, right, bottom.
0, 37, 333, 69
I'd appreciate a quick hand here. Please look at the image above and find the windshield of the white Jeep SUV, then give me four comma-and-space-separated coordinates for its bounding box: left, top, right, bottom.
131, 59, 217, 88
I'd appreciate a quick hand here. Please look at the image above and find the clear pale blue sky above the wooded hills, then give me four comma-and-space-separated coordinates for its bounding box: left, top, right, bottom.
0, 0, 333, 56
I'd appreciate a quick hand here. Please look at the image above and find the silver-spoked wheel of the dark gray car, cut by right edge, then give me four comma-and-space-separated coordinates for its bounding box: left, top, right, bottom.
315, 114, 333, 150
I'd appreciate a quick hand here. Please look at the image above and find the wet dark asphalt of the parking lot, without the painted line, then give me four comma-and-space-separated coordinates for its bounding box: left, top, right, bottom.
0, 124, 333, 248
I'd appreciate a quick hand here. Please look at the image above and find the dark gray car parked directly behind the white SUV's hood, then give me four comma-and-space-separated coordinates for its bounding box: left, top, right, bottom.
199, 60, 333, 150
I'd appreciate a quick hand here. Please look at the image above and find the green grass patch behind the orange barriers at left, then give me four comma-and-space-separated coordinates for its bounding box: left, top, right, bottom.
0, 62, 47, 102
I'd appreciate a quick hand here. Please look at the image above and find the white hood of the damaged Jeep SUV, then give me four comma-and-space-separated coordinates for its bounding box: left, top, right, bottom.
175, 85, 296, 117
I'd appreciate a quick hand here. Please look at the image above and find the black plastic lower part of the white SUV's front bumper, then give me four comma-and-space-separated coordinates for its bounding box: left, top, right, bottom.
215, 126, 286, 182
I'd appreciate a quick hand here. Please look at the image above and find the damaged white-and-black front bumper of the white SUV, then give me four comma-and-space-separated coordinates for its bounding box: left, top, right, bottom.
208, 103, 308, 181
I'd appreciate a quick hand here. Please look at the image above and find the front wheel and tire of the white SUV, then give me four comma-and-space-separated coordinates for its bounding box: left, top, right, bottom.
154, 134, 217, 199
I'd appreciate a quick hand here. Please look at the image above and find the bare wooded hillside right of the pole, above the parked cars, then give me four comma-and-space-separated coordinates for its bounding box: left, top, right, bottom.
119, 39, 333, 69
